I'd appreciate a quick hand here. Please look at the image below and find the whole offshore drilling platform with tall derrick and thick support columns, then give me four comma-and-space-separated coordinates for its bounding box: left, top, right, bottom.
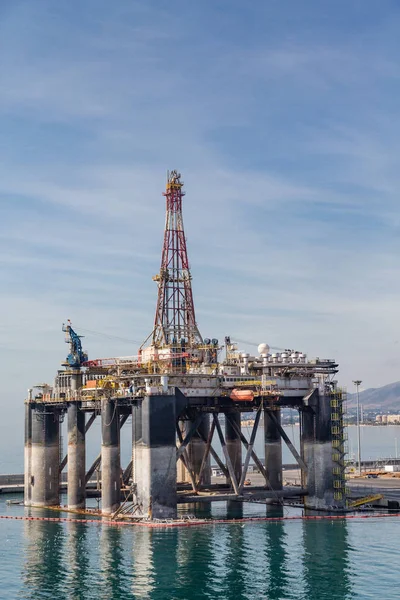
25, 171, 347, 519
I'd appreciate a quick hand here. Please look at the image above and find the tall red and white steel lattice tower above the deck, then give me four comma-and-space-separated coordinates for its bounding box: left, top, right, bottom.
153, 171, 203, 347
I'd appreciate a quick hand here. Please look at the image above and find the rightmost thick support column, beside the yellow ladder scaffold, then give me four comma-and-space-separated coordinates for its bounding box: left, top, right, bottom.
300, 390, 337, 510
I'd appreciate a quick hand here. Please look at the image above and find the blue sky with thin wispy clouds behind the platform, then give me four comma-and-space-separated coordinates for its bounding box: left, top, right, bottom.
0, 0, 400, 442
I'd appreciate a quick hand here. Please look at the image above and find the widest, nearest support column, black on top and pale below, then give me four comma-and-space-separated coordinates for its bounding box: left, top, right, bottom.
135, 395, 177, 519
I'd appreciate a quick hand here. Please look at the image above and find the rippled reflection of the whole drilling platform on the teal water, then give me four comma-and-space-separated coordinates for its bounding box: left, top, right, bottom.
22, 507, 352, 600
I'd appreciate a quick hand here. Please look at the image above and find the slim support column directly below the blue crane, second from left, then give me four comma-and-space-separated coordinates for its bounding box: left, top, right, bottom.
68, 402, 86, 508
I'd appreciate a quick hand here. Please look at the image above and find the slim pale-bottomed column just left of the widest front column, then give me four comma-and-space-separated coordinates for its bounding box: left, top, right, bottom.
101, 399, 121, 515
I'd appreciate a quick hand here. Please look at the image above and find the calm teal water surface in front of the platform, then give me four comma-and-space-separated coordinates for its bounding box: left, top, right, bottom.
0, 500, 400, 600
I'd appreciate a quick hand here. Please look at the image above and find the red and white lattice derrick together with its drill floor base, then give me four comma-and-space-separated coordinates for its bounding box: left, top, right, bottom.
139, 171, 218, 372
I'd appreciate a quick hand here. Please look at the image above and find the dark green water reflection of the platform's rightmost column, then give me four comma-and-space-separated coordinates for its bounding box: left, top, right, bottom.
303, 519, 352, 600
